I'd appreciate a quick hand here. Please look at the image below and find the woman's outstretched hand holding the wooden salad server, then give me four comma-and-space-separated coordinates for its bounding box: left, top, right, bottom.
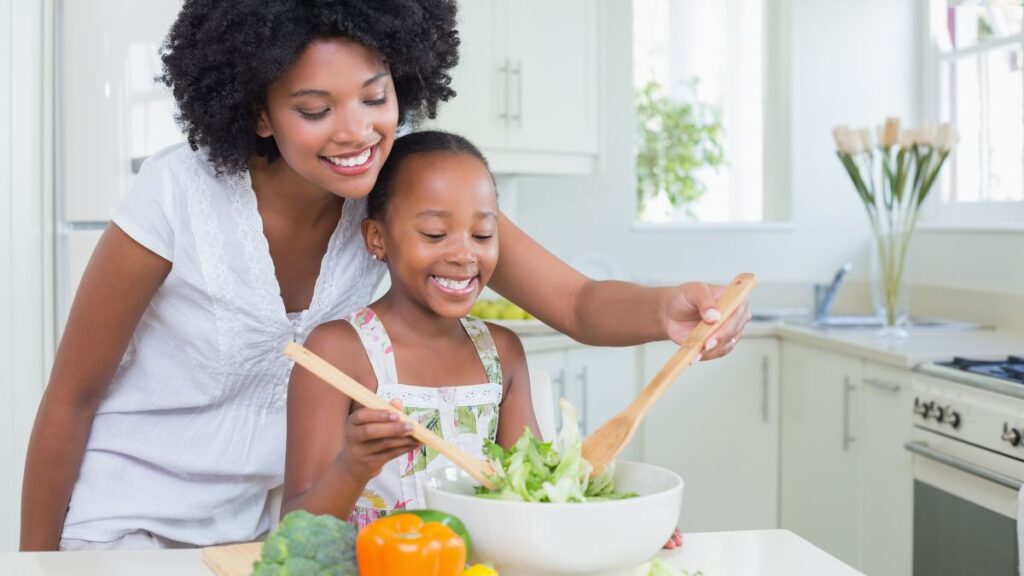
666, 282, 751, 360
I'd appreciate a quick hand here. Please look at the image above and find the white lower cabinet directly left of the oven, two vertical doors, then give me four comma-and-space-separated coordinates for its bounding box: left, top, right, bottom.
781, 342, 912, 576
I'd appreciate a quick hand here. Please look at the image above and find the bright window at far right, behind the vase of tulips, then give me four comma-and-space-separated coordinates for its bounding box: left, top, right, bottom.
925, 0, 1024, 224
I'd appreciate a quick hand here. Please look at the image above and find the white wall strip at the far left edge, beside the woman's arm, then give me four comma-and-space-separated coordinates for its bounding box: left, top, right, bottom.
0, 0, 52, 551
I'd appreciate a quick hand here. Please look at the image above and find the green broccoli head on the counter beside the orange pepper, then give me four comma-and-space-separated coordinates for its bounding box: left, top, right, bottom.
253, 510, 358, 576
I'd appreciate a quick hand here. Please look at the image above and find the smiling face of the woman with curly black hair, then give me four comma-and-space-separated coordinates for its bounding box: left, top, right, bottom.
256, 38, 398, 198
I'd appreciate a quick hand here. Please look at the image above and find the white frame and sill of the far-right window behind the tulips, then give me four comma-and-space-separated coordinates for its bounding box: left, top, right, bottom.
918, 0, 1024, 232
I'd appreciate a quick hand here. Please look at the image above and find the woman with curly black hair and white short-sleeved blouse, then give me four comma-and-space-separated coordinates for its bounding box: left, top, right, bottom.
20, 0, 748, 550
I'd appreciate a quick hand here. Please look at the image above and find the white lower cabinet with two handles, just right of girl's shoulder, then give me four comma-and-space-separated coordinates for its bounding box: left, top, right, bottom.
523, 336, 639, 460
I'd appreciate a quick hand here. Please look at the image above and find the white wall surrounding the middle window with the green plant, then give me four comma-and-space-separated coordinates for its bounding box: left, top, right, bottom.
518, 0, 929, 303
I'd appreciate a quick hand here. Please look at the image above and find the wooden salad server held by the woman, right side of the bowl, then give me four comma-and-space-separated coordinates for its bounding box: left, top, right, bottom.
583, 274, 758, 476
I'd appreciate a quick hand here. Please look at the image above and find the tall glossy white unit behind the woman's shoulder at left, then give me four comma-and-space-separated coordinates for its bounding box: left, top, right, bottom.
54, 0, 184, 335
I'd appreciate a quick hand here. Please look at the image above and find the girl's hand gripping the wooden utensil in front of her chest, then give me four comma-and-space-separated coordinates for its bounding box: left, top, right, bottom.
338, 400, 420, 484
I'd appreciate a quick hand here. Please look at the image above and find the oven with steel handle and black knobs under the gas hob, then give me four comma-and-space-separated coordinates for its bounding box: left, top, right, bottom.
906, 358, 1024, 576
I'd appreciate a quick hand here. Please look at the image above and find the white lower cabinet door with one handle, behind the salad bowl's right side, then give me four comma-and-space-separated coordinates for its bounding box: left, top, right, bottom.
643, 337, 779, 532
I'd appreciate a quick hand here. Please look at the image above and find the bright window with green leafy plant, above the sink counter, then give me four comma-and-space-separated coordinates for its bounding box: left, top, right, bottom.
633, 0, 784, 223
